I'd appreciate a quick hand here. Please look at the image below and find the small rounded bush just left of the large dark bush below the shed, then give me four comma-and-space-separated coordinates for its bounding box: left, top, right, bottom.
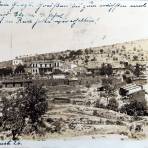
107, 98, 119, 111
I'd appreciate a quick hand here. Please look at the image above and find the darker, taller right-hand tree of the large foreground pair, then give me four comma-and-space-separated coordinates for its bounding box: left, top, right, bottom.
23, 84, 48, 131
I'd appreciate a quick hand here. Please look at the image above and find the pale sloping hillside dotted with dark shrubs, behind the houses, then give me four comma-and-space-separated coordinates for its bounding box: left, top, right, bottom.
0, 39, 148, 67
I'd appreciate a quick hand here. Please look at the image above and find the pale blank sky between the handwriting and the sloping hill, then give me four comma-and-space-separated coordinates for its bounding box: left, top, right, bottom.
0, 0, 148, 61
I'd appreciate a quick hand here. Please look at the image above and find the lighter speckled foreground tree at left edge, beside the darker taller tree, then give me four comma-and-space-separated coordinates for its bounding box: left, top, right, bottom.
2, 96, 26, 140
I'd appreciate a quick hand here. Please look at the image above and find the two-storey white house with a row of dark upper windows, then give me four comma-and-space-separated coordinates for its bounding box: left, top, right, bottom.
31, 60, 64, 75
